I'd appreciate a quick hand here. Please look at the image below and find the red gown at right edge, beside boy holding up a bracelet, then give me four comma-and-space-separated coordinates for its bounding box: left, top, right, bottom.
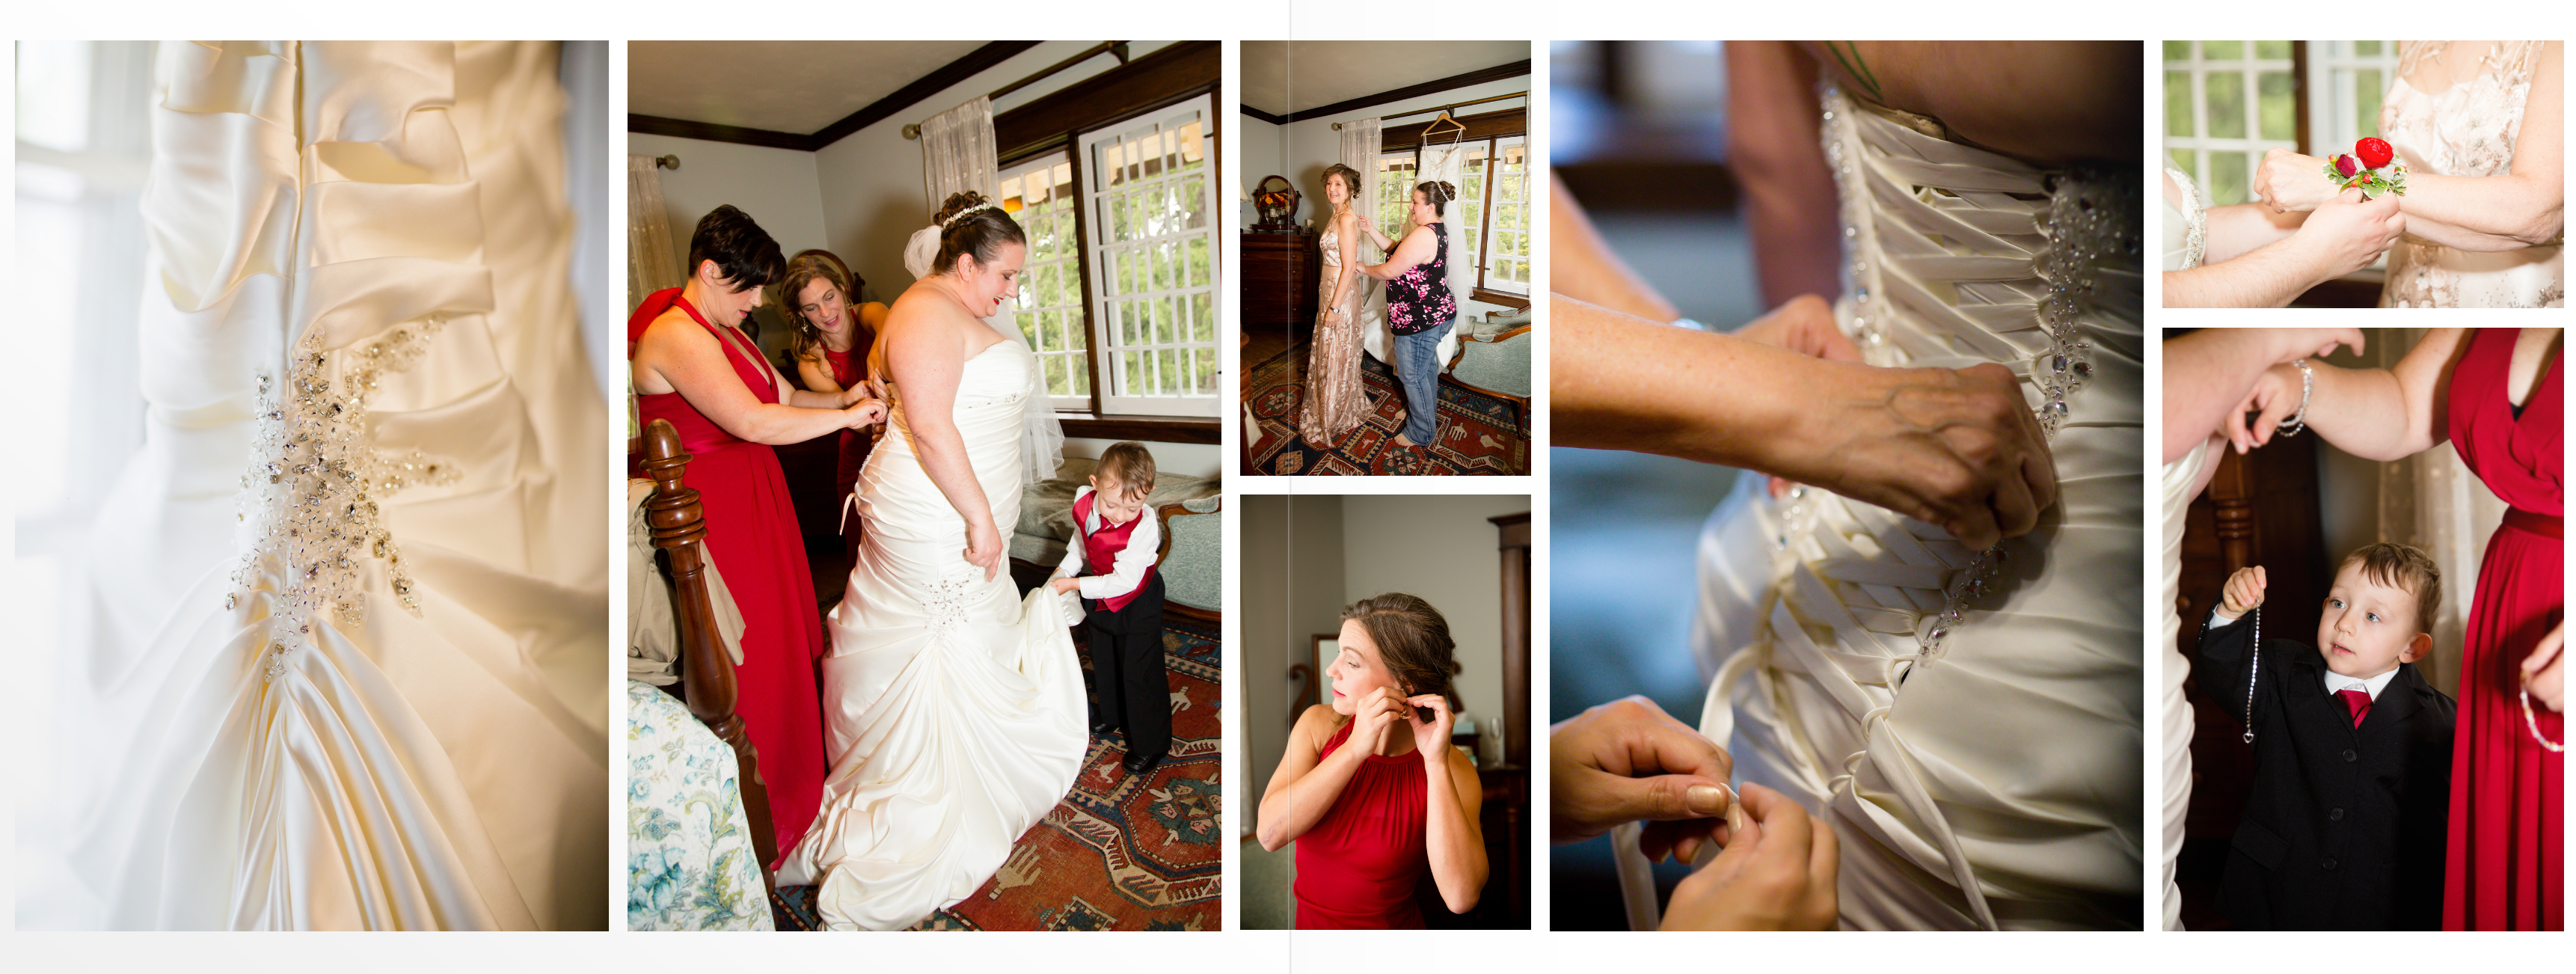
2442, 327, 2566, 930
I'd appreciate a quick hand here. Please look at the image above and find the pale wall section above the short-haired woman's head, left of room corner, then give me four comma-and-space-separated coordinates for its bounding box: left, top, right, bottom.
626, 132, 824, 266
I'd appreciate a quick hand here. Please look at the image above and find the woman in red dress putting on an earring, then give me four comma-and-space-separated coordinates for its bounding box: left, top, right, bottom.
1260, 595, 1486, 930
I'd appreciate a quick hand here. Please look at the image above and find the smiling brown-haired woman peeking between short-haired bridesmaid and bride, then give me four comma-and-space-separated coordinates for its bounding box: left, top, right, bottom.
778, 250, 886, 564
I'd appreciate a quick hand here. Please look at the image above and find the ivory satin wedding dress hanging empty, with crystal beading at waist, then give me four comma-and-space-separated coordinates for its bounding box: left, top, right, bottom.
32, 41, 608, 930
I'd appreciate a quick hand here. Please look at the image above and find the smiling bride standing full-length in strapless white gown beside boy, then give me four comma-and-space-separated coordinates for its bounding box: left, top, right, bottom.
778, 193, 1090, 930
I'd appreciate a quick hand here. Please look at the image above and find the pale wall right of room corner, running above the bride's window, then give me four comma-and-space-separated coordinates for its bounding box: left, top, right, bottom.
814, 41, 1185, 301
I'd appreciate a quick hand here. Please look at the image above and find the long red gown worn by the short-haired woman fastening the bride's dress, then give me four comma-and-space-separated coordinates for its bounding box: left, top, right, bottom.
626, 289, 829, 856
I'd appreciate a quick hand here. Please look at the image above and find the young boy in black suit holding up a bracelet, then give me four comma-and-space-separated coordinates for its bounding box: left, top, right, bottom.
2198, 544, 2455, 930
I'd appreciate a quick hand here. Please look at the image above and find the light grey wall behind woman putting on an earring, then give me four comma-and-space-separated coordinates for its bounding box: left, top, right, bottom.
1342, 494, 1530, 752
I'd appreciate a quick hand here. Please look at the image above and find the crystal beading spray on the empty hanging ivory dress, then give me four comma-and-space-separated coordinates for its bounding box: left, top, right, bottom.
224, 314, 459, 680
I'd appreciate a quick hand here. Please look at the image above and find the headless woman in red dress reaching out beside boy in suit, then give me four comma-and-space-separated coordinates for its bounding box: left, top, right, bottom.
2249, 327, 2566, 930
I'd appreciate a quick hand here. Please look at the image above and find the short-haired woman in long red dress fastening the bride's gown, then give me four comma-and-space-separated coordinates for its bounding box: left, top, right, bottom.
626, 206, 886, 853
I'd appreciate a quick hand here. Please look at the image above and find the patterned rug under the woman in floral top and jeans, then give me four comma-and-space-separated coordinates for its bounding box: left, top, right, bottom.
1244, 343, 1530, 474
